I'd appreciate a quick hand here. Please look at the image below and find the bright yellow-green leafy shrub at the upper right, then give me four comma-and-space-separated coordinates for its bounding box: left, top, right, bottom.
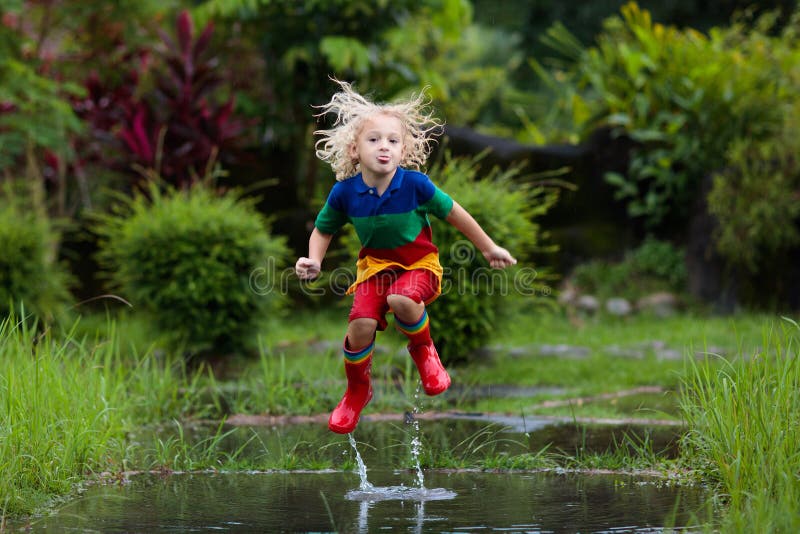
534, 2, 800, 227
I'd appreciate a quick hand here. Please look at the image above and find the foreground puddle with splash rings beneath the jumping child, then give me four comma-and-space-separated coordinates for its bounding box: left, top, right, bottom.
21, 470, 705, 533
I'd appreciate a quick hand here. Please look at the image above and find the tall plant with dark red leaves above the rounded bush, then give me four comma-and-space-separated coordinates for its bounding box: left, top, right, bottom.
119, 11, 246, 191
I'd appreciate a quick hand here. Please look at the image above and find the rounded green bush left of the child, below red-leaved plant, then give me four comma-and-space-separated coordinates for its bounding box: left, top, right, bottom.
98, 186, 288, 358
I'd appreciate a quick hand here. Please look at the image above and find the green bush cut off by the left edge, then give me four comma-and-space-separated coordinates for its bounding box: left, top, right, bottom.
0, 189, 70, 321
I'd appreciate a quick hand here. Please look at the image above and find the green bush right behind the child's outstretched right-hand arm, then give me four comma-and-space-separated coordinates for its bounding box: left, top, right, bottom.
343, 158, 558, 364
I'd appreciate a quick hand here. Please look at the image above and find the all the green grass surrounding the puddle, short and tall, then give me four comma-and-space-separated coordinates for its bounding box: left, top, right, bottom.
6, 310, 800, 531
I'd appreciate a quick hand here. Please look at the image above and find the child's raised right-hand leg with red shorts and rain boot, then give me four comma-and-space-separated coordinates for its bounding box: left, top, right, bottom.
386, 270, 450, 395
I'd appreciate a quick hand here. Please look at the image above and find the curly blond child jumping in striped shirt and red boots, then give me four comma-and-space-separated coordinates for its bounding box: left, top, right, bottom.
295, 80, 516, 434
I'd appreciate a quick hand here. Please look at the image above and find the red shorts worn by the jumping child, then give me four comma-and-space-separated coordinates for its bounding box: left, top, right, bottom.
349, 269, 439, 330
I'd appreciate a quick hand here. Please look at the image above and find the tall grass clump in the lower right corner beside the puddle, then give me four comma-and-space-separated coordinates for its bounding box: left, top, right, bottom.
682, 321, 800, 532
